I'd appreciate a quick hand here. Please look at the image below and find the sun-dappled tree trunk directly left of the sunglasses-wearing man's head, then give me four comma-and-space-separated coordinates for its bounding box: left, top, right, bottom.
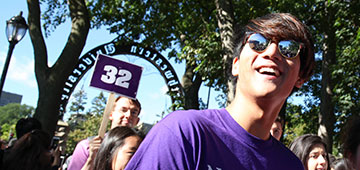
215, 0, 236, 103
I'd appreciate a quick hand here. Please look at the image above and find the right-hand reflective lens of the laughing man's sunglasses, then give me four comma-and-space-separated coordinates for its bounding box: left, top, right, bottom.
279, 40, 300, 58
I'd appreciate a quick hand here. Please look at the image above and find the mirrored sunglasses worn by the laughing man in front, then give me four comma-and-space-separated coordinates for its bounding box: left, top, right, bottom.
246, 33, 302, 59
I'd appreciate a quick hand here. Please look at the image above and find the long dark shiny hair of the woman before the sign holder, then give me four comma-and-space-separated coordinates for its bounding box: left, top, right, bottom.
93, 126, 145, 170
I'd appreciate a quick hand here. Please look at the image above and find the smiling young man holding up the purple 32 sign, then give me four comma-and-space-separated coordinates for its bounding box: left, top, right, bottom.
68, 96, 141, 170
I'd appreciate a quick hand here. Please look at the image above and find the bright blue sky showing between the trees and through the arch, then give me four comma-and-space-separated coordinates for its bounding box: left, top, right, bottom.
0, 0, 224, 123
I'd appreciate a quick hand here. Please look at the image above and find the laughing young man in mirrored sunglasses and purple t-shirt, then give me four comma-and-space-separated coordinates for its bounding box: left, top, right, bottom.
125, 13, 315, 170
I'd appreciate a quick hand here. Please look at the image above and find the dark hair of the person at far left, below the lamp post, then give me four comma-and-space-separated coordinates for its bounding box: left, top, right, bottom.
15, 117, 42, 139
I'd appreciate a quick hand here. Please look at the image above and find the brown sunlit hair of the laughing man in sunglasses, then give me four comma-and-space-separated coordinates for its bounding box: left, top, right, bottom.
233, 13, 315, 81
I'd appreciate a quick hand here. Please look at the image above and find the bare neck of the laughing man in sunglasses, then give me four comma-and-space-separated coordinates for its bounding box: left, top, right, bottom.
226, 93, 285, 140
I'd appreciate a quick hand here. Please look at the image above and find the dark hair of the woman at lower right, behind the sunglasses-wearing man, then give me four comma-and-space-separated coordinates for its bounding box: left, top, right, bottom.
289, 134, 330, 170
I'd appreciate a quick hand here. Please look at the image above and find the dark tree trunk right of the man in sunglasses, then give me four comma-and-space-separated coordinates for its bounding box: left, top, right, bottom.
318, 2, 336, 153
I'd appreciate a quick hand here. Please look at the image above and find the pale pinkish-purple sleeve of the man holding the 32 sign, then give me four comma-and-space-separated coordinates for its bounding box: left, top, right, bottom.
68, 139, 89, 170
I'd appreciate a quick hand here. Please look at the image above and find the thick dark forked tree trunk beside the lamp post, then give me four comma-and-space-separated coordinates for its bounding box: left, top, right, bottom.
27, 0, 90, 135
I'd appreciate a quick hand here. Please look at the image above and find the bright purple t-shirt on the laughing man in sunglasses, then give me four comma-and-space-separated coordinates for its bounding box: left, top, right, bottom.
125, 109, 304, 170
